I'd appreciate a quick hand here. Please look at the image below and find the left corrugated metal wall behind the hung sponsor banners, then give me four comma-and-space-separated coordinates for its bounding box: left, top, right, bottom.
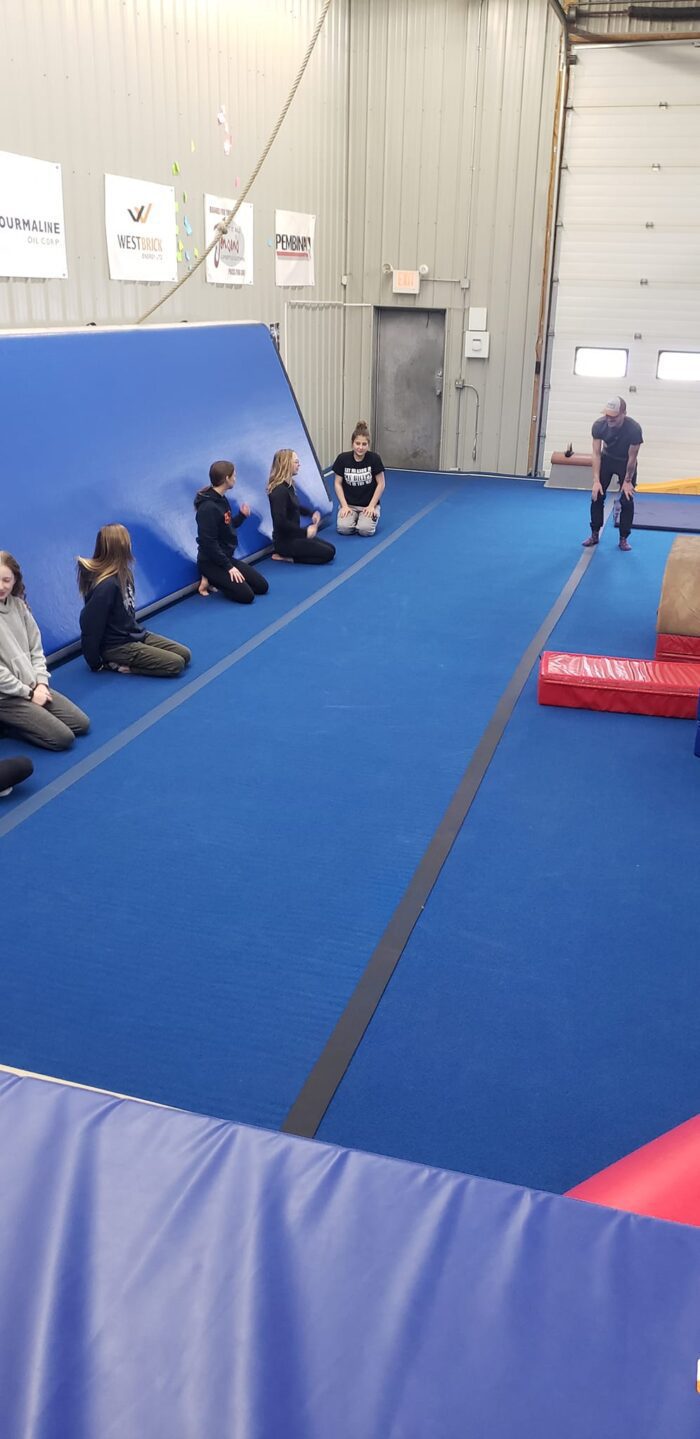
0, 0, 349, 450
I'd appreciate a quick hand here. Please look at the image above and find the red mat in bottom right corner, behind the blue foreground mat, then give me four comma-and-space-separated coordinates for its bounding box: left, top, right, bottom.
569, 1115, 700, 1225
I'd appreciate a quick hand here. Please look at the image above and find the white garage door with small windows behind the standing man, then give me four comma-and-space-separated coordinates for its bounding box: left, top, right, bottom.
542, 43, 700, 481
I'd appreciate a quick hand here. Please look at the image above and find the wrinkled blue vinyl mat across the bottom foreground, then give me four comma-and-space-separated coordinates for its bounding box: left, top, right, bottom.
0, 1075, 700, 1439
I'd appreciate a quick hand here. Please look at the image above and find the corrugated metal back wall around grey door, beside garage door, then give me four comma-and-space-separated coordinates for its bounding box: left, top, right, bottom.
344, 0, 560, 472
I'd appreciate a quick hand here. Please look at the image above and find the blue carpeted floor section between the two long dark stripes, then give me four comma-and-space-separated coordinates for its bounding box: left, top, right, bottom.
0, 481, 596, 1125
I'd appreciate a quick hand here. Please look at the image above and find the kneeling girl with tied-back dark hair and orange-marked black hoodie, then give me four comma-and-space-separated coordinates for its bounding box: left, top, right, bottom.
194, 459, 269, 604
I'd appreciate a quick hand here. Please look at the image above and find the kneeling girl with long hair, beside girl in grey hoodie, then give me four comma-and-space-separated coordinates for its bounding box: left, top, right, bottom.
78, 525, 192, 678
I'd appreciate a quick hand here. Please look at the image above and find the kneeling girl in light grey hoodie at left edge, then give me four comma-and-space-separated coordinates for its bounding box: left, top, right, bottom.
0, 550, 89, 754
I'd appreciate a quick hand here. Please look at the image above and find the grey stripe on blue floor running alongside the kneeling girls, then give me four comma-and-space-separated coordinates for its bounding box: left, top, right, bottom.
0, 489, 452, 839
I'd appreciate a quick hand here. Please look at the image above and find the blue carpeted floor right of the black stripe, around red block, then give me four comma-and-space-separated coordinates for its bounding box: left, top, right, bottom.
318, 534, 700, 1190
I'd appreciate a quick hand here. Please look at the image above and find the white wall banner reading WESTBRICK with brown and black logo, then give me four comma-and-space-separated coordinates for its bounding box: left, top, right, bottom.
105, 176, 177, 281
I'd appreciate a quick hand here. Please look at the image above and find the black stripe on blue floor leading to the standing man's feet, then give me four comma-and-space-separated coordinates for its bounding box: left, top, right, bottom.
282, 529, 595, 1138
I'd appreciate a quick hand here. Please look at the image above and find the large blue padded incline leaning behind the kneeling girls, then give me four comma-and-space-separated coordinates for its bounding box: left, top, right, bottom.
0, 324, 331, 653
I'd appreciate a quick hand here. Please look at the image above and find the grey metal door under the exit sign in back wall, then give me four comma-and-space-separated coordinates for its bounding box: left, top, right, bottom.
373, 309, 445, 469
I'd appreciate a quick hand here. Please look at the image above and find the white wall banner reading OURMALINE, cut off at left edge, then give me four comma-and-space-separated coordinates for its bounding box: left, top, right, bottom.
0, 150, 68, 279
